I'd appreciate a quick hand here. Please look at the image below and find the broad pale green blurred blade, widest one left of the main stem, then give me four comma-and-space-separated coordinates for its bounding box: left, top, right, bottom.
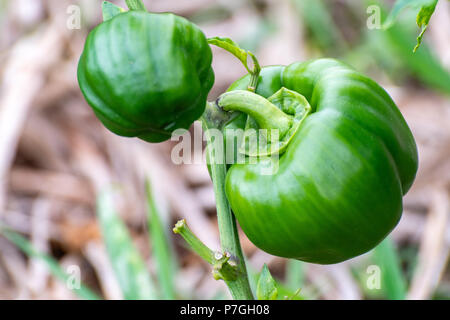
97, 190, 157, 300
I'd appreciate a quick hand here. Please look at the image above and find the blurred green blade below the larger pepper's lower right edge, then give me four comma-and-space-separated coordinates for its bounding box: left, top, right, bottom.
372, 238, 407, 300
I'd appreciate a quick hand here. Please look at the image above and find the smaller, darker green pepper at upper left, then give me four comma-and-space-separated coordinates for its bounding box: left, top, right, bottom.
78, 11, 214, 142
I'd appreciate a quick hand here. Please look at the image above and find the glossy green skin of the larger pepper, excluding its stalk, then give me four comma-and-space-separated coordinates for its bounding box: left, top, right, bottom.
226, 59, 418, 264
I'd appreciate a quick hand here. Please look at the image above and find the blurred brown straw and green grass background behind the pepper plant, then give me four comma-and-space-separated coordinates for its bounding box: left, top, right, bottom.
0, 0, 450, 299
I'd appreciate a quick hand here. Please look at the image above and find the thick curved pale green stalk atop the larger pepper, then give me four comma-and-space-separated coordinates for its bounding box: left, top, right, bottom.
217, 90, 293, 138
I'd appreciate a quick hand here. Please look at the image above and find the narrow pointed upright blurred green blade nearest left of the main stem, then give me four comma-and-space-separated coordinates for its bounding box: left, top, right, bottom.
147, 181, 176, 300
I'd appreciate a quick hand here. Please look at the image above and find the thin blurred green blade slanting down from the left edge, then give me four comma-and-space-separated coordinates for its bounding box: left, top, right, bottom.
0, 226, 100, 300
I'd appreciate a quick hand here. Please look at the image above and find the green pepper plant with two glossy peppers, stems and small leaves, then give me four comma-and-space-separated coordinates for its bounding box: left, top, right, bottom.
74, 0, 418, 299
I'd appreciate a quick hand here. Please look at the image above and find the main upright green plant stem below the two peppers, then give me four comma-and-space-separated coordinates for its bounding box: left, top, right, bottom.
201, 103, 254, 300
